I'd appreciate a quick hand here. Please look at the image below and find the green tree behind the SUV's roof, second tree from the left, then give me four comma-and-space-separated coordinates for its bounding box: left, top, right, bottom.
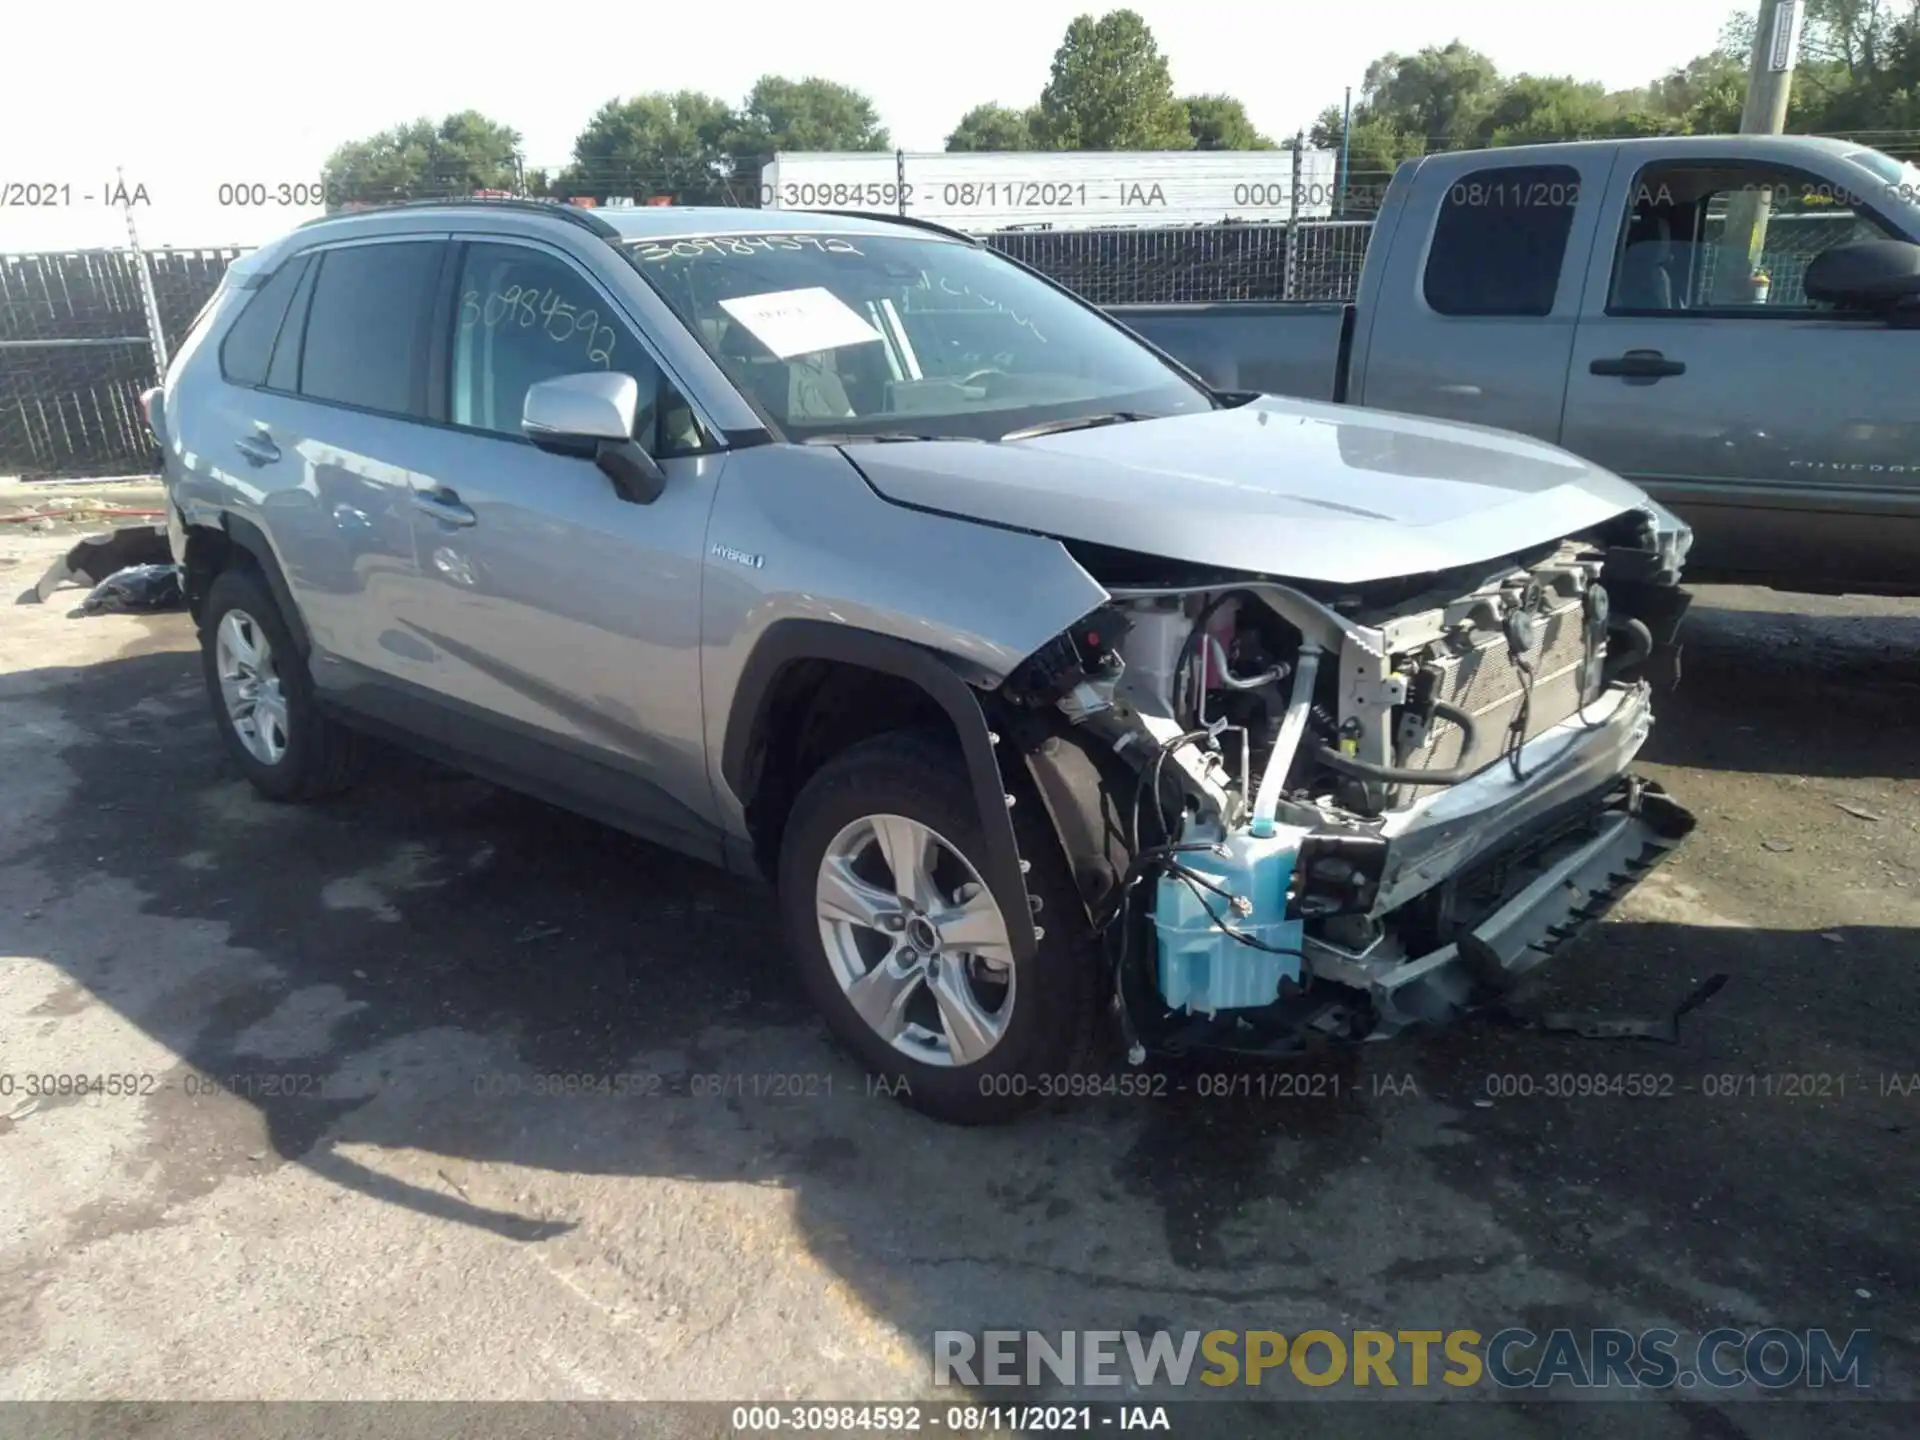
553, 90, 735, 205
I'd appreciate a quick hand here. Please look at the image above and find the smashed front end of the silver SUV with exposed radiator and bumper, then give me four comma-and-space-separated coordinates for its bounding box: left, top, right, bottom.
991, 511, 1693, 1062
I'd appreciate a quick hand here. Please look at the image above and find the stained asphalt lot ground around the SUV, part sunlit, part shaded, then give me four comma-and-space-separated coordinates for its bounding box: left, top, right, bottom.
0, 526, 1920, 1440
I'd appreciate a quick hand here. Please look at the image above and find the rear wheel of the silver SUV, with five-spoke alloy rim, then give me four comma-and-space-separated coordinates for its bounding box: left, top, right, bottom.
200, 570, 359, 814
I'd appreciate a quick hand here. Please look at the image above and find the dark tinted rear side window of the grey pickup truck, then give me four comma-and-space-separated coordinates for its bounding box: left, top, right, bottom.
1423, 165, 1580, 315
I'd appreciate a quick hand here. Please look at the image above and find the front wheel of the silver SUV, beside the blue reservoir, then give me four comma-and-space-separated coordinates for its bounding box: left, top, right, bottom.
780, 733, 1096, 1125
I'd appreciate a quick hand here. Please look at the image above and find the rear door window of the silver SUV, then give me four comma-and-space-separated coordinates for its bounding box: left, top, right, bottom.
300, 240, 444, 419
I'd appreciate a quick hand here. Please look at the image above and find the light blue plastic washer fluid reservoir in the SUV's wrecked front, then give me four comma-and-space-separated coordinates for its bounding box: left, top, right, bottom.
1154, 826, 1308, 1016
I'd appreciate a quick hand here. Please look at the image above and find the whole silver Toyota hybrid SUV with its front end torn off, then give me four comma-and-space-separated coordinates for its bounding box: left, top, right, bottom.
148, 202, 1692, 1121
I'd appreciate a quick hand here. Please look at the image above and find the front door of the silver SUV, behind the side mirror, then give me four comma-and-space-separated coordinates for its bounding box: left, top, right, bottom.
396, 234, 724, 858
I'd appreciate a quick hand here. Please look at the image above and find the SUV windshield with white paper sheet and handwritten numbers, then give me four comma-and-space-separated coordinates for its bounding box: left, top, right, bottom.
628, 232, 1213, 442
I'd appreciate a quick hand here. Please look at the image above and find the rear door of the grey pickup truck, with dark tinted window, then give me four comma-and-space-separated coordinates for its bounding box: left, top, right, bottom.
1348, 146, 1617, 442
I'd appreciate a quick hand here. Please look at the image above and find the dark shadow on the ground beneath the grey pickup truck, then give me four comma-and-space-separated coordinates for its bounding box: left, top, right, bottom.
1645, 605, 1920, 780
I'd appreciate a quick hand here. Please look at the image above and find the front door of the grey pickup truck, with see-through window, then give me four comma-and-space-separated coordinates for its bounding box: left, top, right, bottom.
1561, 150, 1920, 589
